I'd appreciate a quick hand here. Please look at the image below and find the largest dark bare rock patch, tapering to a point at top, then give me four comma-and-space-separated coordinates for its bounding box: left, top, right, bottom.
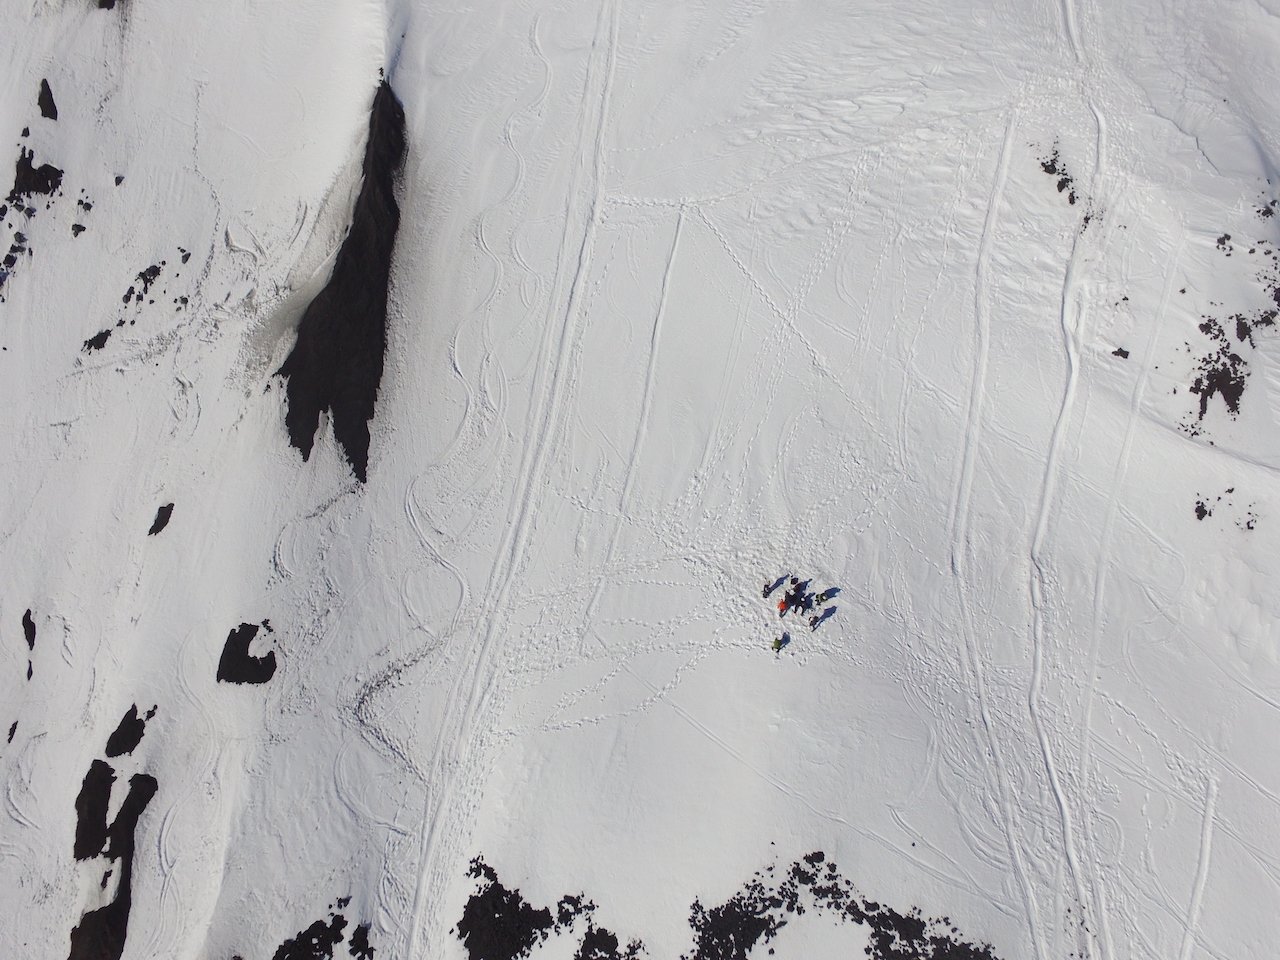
279, 81, 404, 483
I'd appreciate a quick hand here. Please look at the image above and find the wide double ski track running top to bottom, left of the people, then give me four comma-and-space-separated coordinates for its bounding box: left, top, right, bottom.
407, 3, 618, 957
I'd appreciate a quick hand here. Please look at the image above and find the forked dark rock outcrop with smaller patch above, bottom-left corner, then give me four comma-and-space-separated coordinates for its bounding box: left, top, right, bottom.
68, 721, 160, 960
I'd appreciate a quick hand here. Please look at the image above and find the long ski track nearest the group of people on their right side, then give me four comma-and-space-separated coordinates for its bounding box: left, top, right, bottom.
951, 111, 1047, 960
